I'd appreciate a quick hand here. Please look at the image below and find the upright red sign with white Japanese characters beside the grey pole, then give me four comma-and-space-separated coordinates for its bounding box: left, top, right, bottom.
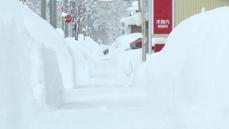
153, 0, 173, 34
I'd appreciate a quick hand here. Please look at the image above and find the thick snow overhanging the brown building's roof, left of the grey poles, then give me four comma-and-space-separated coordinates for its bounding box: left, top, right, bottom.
120, 13, 142, 26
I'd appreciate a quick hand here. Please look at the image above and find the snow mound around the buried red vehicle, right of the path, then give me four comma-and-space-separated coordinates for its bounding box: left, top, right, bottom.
109, 33, 142, 85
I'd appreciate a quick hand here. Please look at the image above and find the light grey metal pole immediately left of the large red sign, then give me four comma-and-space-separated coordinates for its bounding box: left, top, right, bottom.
148, 0, 154, 54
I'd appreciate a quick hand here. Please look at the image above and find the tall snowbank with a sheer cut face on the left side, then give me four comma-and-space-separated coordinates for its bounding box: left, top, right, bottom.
0, 0, 73, 129
